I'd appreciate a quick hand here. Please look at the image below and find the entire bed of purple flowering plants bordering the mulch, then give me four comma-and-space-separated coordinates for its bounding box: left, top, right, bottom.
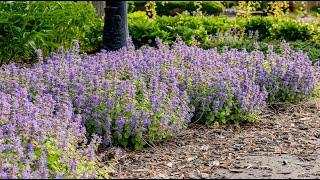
0, 39, 319, 178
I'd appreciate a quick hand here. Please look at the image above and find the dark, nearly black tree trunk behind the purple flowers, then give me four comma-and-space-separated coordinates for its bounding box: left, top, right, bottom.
102, 0, 129, 51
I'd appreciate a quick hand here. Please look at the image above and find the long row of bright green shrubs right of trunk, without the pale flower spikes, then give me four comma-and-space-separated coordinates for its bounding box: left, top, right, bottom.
129, 12, 316, 47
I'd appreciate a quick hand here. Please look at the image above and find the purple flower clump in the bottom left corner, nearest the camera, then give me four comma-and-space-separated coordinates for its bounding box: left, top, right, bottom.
0, 87, 108, 179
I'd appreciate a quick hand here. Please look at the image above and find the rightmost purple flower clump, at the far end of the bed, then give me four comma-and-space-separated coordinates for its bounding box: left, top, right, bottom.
223, 42, 320, 103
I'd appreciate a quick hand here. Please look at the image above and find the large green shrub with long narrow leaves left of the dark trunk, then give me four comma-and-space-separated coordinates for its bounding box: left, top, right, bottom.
0, 1, 103, 64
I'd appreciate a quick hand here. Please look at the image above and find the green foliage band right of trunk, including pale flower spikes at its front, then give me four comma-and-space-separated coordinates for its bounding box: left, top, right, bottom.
128, 11, 320, 62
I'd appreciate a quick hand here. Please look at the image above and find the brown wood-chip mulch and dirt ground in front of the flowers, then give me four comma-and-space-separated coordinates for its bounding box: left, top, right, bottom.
109, 99, 320, 179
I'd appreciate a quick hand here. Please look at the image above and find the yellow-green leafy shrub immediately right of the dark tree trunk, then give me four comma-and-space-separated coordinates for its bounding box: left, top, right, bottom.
128, 13, 234, 47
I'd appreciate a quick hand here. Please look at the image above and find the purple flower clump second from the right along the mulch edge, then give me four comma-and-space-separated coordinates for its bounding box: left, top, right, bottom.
166, 39, 267, 123
